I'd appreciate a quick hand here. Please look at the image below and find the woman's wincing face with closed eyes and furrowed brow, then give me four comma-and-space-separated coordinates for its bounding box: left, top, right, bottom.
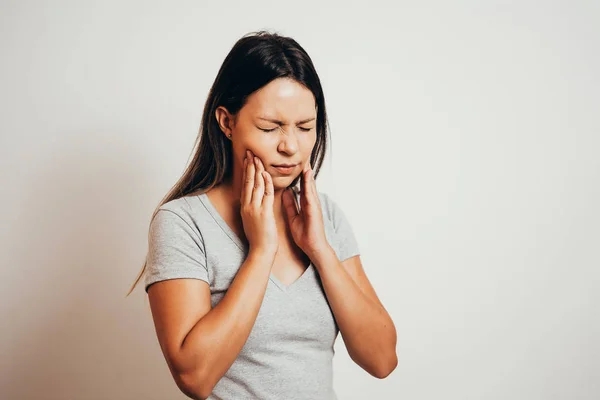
217, 78, 317, 190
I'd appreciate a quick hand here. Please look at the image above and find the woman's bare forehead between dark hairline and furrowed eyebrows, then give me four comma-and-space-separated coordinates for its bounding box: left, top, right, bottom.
244, 78, 316, 120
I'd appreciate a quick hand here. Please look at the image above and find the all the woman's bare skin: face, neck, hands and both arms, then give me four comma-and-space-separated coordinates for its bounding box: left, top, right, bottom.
148, 79, 398, 399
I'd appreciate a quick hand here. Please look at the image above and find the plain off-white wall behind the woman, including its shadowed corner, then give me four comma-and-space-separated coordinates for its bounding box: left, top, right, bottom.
0, 0, 600, 400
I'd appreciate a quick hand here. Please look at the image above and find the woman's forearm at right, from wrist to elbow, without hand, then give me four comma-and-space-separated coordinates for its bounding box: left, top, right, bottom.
313, 247, 397, 378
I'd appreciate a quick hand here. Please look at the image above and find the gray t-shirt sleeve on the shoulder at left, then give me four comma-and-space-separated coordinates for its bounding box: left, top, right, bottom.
144, 209, 209, 293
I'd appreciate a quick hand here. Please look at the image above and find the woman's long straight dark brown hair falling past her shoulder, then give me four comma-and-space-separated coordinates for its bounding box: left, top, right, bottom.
127, 31, 329, 296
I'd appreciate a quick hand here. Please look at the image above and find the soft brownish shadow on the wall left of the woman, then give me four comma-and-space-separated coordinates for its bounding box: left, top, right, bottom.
0, 131, 186, 400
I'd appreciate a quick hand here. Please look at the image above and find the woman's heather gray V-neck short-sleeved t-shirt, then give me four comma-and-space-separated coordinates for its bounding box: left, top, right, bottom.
145, 192, 359, 400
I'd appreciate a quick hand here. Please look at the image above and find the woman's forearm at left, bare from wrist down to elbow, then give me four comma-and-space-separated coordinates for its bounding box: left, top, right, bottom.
175, 251, 274, 395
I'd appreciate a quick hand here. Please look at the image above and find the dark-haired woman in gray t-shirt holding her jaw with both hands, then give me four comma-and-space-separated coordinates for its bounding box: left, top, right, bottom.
130, 32, 397, 400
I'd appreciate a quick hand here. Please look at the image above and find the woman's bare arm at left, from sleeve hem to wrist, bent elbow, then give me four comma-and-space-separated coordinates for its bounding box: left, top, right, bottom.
148, 250, 275, 399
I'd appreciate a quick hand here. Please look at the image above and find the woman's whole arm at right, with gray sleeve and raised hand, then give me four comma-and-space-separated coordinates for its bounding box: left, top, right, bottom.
283, 162, 398, 379
